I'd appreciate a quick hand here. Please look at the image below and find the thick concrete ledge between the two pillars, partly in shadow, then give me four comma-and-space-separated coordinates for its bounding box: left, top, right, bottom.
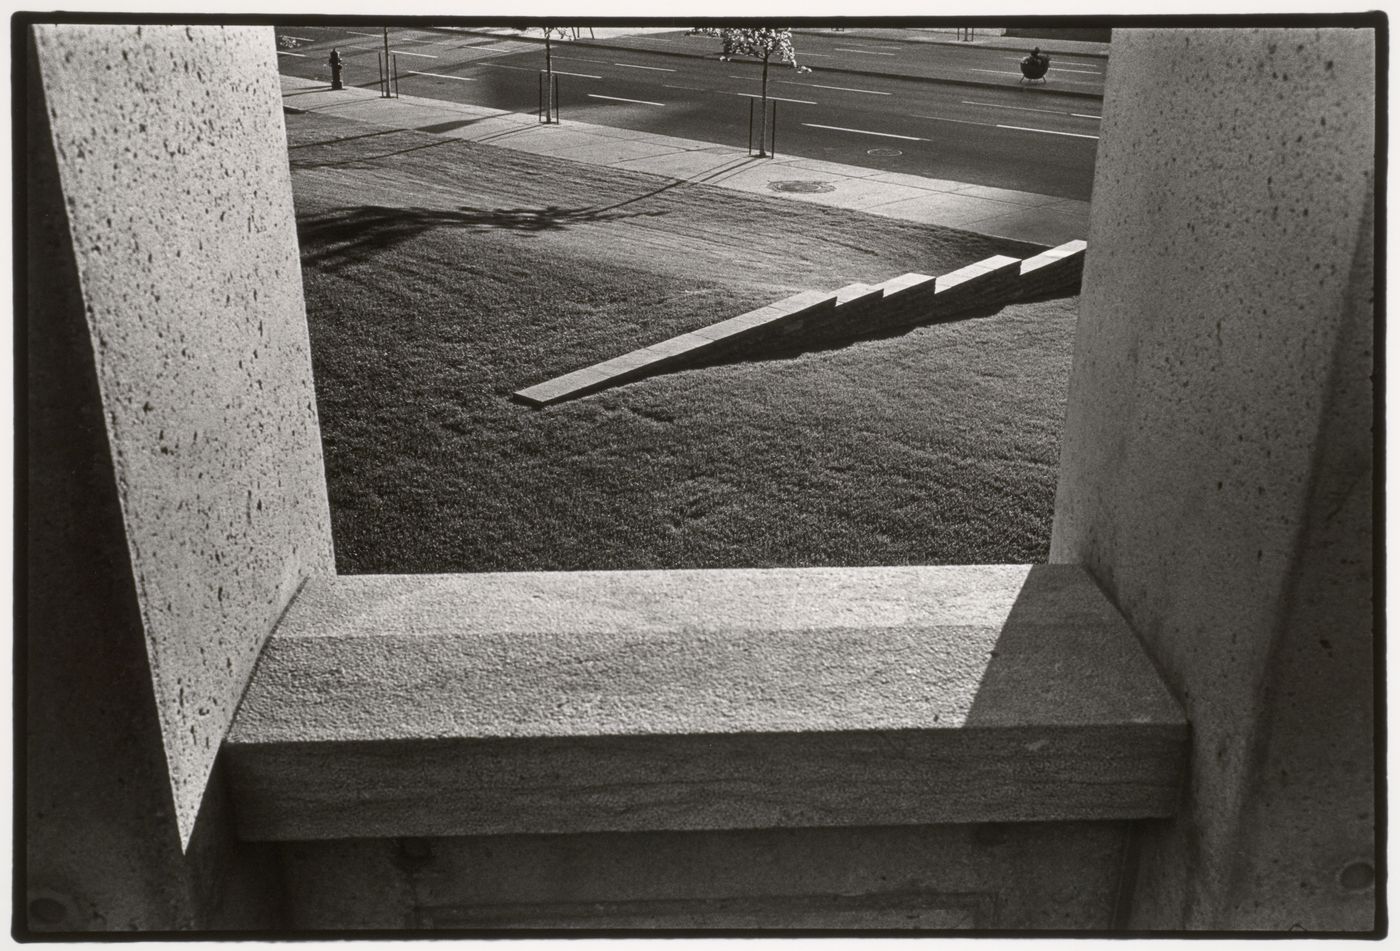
225, 566, 1187, 839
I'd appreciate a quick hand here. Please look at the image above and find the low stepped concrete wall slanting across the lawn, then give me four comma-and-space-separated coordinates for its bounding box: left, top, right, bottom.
512, 241, 1086, 406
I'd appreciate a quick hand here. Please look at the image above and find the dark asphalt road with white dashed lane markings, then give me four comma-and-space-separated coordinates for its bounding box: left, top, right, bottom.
277, 27, 1106, 200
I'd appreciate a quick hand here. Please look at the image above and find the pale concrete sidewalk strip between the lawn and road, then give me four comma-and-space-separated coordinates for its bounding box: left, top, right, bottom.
281, 76, 1089, 247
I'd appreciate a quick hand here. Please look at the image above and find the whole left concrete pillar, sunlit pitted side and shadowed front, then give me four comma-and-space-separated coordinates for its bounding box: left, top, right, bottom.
25, 25, 333, 930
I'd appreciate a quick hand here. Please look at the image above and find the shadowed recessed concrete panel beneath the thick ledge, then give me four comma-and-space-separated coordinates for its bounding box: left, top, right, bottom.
281, 822, 1128, 929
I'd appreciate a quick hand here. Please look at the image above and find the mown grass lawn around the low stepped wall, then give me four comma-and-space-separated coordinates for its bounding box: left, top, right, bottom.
287, 115, 1077, 573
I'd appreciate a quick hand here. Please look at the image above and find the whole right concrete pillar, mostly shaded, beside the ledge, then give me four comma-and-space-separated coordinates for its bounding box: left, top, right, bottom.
1051, 28, 1376, 930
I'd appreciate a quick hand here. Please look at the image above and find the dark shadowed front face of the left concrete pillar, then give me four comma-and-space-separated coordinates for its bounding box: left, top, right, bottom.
24, 26, 291, 934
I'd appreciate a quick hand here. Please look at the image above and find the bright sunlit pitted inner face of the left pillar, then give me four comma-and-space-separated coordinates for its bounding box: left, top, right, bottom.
35, 25, 333, 842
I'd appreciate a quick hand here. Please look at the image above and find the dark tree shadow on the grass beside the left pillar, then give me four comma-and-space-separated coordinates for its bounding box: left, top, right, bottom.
297, 200, 665, 270
